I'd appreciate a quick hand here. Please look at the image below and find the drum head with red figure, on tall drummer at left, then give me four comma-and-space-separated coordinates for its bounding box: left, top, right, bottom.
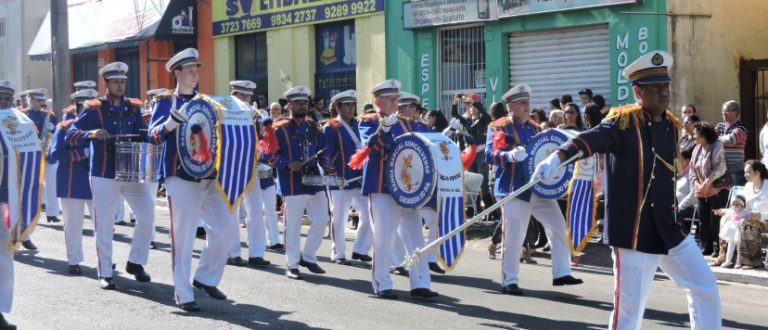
176, 99, 218, 178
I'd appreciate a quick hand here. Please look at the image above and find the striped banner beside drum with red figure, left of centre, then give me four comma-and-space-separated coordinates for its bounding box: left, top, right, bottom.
214, 96, 259, 212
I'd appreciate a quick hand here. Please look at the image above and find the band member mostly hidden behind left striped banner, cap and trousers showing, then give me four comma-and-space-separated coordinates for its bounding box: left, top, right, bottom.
227, 80, 274, 267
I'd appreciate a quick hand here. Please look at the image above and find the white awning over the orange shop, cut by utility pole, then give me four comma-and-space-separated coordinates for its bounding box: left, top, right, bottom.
27, 0, 172, 60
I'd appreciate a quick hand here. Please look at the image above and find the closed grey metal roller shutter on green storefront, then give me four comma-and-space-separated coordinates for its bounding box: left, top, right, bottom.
509, 25, 611, 110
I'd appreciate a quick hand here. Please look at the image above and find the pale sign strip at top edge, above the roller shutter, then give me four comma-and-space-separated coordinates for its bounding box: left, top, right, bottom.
498, 0, 642, 18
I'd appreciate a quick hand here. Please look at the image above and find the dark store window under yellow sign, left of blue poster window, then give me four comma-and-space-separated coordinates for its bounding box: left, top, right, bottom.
235, 32, 268, 104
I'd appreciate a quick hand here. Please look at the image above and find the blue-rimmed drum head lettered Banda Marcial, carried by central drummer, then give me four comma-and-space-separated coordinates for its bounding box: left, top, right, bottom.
384, 133, 437, 208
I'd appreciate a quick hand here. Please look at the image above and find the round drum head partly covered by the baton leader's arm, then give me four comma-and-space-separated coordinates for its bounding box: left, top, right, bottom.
525, 129, 576, 199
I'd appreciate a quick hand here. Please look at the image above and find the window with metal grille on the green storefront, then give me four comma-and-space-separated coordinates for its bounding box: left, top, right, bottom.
437, 25, 485, 114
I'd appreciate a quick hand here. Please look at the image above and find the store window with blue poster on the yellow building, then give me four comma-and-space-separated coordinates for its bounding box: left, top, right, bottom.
313, 20, 357, 111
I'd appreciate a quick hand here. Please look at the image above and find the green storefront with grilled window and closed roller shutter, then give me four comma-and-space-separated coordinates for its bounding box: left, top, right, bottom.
385, 0, 667, 110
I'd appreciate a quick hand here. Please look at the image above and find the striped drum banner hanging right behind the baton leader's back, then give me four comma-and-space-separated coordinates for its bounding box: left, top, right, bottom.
566, 155, 600, 254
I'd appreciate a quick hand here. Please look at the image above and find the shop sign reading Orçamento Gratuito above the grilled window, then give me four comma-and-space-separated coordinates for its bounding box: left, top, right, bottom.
403, 0, 498, 29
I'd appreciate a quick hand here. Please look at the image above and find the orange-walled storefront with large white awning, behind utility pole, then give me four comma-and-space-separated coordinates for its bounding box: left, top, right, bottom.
28, 0, 206, 98
